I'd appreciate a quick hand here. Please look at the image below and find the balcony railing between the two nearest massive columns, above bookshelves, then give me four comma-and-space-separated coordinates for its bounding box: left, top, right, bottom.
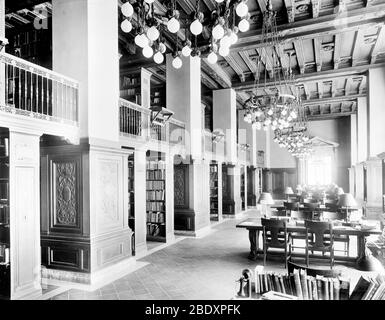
119, 99, 186, 147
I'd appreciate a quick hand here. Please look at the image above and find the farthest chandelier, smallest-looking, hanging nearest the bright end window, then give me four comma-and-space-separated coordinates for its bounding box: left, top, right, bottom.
274, 97, 313, 158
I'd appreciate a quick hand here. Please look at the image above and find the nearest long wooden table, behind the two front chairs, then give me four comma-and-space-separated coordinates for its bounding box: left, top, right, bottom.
236, 218, 381, 264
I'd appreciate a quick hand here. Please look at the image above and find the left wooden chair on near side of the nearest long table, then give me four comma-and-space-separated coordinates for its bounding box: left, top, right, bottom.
261, 218, 291, 268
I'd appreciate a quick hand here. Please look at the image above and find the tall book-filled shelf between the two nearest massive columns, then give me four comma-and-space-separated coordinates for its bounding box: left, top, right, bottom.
146, 154, 166, 242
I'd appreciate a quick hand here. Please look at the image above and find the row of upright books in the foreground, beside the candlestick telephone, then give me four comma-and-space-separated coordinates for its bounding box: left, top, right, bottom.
254, 266, 350, 300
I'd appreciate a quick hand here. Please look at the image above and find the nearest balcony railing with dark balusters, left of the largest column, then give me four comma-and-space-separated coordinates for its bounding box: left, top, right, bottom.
0, 52, 79, 134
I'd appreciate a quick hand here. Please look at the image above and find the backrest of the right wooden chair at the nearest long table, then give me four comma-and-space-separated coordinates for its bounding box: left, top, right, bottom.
305, 220, 333, 250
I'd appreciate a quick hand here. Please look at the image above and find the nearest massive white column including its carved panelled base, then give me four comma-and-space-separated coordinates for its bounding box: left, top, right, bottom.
42, 0, 131, 284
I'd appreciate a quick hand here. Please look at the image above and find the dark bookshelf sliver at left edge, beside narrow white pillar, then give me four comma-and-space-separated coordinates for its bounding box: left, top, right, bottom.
0, 133, 10, 300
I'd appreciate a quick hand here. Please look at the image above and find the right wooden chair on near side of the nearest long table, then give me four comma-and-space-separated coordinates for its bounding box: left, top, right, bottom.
305, 220, 334, 269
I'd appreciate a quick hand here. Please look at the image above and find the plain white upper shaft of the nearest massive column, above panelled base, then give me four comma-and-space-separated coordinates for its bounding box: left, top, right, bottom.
52, 0, 119, 141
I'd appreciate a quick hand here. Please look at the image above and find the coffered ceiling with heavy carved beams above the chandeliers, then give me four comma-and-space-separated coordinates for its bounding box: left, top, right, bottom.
122, 0, 385, 119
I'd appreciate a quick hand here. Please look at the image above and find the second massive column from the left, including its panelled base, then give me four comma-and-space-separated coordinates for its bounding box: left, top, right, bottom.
166, 54, 210, 235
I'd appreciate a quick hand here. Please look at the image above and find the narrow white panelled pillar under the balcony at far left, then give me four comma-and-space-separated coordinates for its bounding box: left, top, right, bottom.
9, 130, 41, 299
